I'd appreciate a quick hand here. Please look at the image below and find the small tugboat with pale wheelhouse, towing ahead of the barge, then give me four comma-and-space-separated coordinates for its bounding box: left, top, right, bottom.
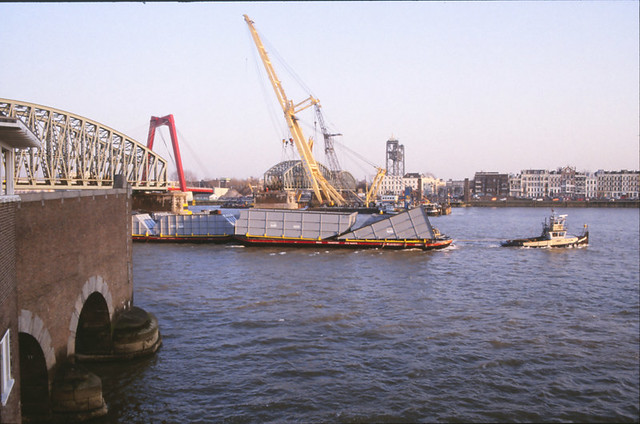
501, 210, 589, 247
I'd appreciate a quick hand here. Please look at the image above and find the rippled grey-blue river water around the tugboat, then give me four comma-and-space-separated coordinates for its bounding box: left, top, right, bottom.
91, 208, 640, 423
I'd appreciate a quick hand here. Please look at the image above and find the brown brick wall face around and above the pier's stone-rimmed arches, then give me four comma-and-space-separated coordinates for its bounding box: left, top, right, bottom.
16, 189, 133, 370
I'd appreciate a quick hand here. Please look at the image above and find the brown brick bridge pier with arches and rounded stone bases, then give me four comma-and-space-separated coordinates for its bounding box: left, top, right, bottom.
0, 188, 161, 423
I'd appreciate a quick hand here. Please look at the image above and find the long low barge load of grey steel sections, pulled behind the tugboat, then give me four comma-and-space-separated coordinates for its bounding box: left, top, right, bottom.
132, 208, 452, 250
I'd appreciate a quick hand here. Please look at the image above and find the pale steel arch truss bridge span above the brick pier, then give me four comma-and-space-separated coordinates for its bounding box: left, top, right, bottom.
0, 98, 169, 190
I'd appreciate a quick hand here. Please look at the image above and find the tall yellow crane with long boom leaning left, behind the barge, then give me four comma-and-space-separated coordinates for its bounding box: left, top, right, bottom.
244, 15, 346, 206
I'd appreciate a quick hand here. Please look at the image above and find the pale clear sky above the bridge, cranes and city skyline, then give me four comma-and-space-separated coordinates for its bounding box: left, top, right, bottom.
0, 1, 640, 181
